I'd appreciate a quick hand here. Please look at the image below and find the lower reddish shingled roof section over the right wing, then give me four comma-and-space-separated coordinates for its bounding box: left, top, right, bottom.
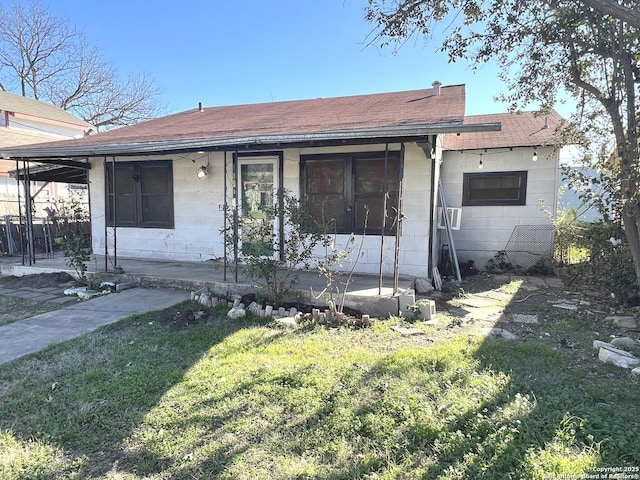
444, 110, 564, 150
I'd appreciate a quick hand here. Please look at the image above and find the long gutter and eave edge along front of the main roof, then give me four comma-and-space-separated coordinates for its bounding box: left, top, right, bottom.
0, 122, 501, 160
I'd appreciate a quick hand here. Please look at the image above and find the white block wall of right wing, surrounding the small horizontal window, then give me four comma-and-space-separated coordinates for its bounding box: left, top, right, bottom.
439, 147, 558, 270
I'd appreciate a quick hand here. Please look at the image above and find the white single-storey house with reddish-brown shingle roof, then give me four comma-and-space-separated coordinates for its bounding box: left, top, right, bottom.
0, 82, 557, 277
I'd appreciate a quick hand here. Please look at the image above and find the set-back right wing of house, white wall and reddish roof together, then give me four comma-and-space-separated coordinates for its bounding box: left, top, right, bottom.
442, 111, 563, 270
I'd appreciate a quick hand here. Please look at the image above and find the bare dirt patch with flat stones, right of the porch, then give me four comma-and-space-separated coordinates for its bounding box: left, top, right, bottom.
420, 274, 640, 362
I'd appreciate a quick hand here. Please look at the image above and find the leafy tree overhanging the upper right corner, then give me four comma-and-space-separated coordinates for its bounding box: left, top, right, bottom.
366, 0, 640, 296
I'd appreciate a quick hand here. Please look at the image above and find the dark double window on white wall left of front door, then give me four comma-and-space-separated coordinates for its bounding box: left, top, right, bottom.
106, 160, 173, 228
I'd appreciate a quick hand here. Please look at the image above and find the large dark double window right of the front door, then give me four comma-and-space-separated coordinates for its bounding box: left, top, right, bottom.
301, 152, 401, 234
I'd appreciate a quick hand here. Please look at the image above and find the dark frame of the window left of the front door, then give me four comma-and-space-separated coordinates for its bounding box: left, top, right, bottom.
104, 160, 175, 229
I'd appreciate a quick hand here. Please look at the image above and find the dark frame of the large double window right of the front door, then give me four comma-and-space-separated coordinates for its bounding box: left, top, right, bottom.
300, 150, 403, 235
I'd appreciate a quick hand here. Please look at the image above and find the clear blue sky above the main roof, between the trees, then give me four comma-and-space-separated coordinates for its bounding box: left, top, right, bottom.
39, 0, 571, 116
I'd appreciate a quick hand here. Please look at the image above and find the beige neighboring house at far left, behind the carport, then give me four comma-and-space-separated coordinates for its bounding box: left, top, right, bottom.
0, 91, 91, 216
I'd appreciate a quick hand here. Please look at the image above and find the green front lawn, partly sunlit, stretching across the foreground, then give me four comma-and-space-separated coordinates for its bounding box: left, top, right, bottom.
0, 302, 640, 480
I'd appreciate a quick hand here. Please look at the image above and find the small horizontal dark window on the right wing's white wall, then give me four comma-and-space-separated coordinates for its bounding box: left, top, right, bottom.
462, 172, 527, 206
